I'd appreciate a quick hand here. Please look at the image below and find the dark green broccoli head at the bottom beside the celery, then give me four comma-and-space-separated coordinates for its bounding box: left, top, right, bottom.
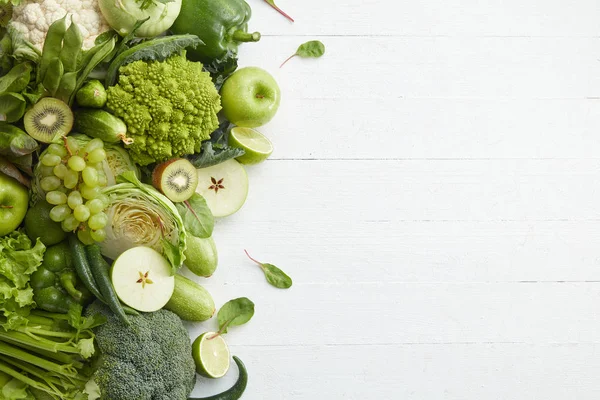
86, 301, 196, 400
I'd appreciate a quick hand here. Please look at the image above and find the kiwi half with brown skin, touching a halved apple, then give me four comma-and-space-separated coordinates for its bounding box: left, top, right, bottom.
152, 158, 198, 202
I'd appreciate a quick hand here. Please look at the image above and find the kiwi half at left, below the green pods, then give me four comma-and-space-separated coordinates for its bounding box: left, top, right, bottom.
24, 97, 73, 143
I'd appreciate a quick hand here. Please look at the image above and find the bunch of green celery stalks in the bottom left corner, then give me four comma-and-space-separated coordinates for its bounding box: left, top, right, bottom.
0, 306, 104, 399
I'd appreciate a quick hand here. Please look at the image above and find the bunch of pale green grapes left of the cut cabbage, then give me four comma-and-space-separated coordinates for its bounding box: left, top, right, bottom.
40, 138, 108, 244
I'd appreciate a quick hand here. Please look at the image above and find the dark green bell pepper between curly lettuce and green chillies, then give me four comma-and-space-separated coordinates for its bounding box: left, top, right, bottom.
30, 242, 92, 313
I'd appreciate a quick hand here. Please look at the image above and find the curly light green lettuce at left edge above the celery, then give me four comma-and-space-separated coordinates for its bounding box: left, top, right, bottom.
0, 230, 46, 329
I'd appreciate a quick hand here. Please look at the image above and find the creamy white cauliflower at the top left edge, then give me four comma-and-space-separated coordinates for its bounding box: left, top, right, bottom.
10, 0, 110, 51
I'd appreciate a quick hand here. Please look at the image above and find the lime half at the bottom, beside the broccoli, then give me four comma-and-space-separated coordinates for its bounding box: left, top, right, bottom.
192, 332, 230, 378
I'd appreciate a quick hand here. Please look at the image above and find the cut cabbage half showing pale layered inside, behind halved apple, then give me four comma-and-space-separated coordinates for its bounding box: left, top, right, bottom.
100, 171, 186, 273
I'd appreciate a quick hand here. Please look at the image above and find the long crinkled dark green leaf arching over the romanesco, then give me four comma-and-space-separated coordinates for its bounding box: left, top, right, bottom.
105, 35, 204, 87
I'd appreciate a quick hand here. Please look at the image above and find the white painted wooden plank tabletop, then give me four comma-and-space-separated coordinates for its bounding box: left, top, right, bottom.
186, 0, 600, 400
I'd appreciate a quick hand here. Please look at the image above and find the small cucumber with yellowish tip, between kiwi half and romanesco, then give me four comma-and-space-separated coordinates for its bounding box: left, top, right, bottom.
74, 110, 133, 144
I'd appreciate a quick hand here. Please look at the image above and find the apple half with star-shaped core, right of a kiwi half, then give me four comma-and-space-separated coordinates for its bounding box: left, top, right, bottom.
196, 160, 248, 217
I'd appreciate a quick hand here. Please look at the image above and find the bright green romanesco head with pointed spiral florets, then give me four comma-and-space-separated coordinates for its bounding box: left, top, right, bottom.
106, 54, 221, 165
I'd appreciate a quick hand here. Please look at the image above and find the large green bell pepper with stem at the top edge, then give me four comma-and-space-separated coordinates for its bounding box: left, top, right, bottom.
171, 0, 260, 63
